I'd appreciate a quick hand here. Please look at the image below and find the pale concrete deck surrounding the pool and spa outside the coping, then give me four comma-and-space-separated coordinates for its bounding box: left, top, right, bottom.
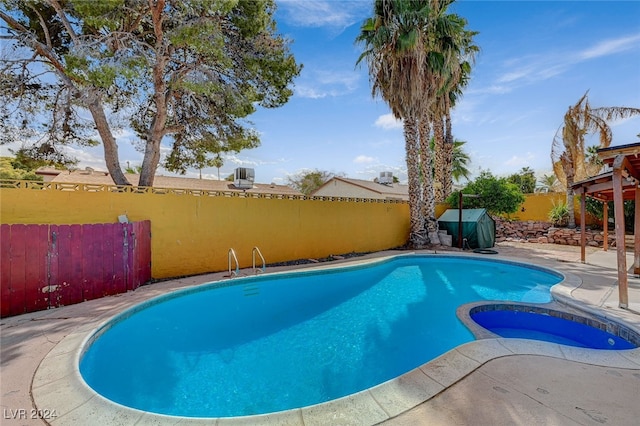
0, 243, 640, 426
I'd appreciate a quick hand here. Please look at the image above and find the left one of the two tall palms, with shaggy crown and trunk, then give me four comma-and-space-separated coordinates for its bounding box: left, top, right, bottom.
356, 0, 438, 247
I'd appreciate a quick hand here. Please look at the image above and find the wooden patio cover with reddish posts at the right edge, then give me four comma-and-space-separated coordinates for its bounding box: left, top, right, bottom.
571, 143, 640, 308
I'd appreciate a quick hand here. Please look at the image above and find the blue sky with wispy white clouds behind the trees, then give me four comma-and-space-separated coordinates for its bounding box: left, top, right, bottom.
6, 0, 640, 183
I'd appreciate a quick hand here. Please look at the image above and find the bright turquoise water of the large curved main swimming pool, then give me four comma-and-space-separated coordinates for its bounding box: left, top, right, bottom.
80, 255, 562, 417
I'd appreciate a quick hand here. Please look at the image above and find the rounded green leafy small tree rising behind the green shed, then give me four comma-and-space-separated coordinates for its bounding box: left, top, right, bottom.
447, 170, 525, 215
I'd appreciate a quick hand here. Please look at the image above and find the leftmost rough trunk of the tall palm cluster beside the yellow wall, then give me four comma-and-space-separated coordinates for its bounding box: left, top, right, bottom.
404, 118, 426, 248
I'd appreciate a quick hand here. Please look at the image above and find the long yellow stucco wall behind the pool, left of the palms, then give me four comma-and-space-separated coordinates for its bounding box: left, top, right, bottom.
0, 187, 409, 279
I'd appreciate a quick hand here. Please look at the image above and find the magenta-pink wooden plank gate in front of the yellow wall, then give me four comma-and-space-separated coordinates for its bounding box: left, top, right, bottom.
0, 221, 151, 317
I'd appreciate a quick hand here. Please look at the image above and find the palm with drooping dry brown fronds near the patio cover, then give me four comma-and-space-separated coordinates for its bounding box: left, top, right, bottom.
551, 91, 640, 228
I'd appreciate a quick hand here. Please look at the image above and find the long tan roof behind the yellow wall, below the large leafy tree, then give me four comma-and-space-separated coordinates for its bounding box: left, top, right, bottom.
52, 169, 303, 195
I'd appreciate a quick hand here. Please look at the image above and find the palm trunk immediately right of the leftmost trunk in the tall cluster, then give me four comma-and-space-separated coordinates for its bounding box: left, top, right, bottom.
419, 114, 440, 240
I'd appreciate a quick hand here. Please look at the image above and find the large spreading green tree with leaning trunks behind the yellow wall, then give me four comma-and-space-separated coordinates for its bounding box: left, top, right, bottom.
0, 0, 300, 186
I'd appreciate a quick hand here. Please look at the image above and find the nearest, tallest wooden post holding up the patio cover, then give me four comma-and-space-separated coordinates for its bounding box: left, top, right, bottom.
612, 155, 629, 309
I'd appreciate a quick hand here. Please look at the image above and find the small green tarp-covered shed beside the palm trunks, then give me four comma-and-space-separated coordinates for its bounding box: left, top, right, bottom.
438, 209, 496, 249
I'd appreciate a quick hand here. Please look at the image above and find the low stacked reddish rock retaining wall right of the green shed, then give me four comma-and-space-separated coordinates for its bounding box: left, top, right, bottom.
494, 217, 615, 247
